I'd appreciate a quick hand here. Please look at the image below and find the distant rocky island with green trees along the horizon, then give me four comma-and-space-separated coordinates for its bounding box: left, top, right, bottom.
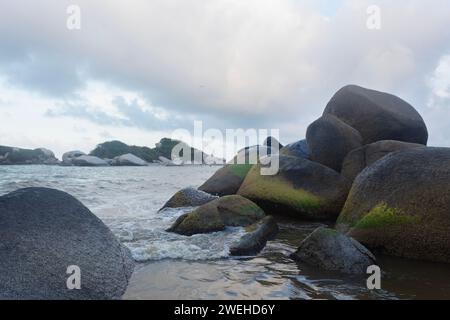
0, 138, 224, 167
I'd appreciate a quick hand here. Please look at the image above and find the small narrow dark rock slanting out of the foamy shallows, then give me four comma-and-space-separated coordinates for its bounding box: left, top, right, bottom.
230, 216, 278, 256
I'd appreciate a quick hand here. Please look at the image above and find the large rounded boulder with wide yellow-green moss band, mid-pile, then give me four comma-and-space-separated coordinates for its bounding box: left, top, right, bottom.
237, 156, 349, 220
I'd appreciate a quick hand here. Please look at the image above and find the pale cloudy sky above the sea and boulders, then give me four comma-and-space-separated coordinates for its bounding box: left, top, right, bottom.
0, 0, 450, 159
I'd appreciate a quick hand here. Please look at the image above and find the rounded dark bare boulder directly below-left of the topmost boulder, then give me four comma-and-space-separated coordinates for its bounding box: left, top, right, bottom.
306, 114, 362, 172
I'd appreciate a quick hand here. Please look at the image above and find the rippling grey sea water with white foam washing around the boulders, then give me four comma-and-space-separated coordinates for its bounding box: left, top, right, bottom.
0, 165, 450, 299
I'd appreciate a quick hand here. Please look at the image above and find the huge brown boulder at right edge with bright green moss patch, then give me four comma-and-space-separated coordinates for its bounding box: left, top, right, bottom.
337, 147, 450, 263
